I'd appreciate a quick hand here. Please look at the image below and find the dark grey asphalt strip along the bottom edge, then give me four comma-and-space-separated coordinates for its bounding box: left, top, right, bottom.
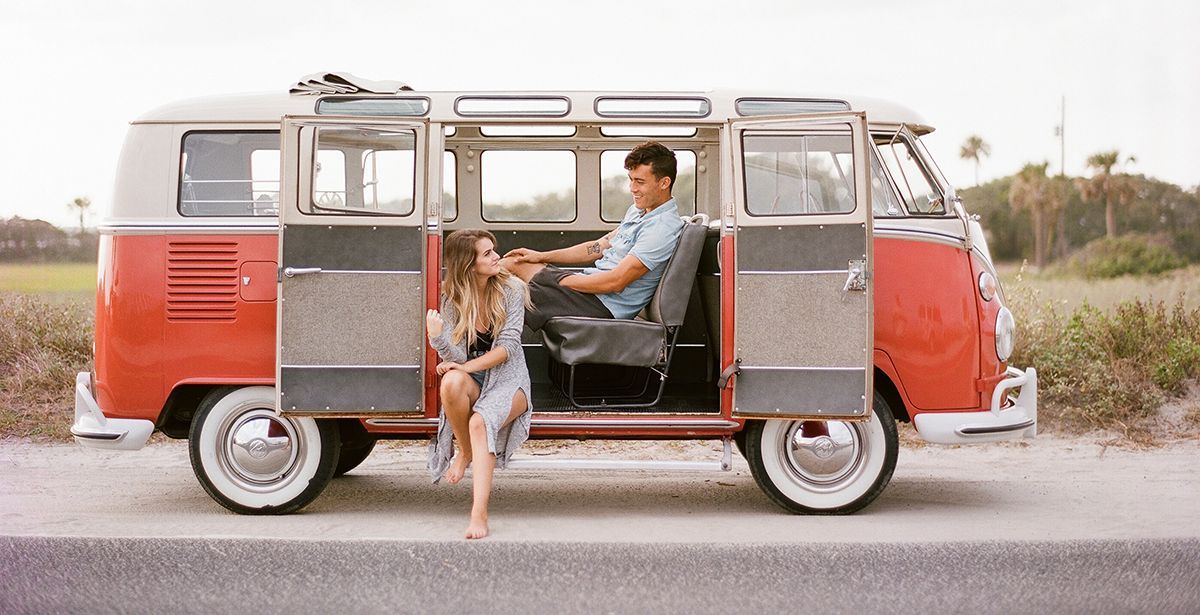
0, 537, 1200, 614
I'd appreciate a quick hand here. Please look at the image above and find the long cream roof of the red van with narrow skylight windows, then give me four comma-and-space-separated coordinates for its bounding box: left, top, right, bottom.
133, 90, 934, 133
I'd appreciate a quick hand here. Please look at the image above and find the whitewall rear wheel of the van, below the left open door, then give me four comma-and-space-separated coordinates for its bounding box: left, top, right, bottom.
187, 387, 341, 514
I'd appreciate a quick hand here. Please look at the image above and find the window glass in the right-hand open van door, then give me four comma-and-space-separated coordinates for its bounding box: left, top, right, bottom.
743, 135, 854, 216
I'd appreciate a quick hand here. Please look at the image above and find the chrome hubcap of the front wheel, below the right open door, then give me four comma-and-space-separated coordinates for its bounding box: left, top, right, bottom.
780, 420, 864, 489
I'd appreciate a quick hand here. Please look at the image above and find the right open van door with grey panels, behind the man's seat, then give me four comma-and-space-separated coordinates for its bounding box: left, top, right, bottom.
724, 112, 874, 420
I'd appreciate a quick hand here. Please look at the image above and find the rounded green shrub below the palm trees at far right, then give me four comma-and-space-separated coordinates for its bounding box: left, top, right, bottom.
1067, 234, 1187, 279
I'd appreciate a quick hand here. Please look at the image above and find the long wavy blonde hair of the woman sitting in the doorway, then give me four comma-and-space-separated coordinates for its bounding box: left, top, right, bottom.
442, 228, 528, 346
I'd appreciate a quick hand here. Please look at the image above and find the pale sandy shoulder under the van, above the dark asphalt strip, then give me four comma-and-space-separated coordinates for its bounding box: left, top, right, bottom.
0, 437, 1200, 543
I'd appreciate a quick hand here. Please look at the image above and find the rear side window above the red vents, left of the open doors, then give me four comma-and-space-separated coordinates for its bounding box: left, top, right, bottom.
179, 131, 280, 216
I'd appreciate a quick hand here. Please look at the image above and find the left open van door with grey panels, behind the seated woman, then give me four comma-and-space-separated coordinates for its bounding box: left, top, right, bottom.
276, 115, 443, 416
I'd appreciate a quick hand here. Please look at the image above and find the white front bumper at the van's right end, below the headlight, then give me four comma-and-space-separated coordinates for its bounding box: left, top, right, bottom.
912, 368, 1038, 444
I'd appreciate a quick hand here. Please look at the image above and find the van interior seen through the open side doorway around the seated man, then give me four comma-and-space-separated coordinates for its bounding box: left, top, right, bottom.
443, 124, 721, 414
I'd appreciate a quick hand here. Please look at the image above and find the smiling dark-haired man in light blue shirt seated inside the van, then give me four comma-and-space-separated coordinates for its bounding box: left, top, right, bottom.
500, 141, 683, 330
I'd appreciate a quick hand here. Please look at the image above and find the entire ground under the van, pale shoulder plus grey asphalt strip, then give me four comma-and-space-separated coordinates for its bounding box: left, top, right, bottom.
0, 438, 1200, 614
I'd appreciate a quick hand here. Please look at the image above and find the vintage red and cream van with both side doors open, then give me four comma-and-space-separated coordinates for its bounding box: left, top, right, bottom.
72, 78, 1037, 513
